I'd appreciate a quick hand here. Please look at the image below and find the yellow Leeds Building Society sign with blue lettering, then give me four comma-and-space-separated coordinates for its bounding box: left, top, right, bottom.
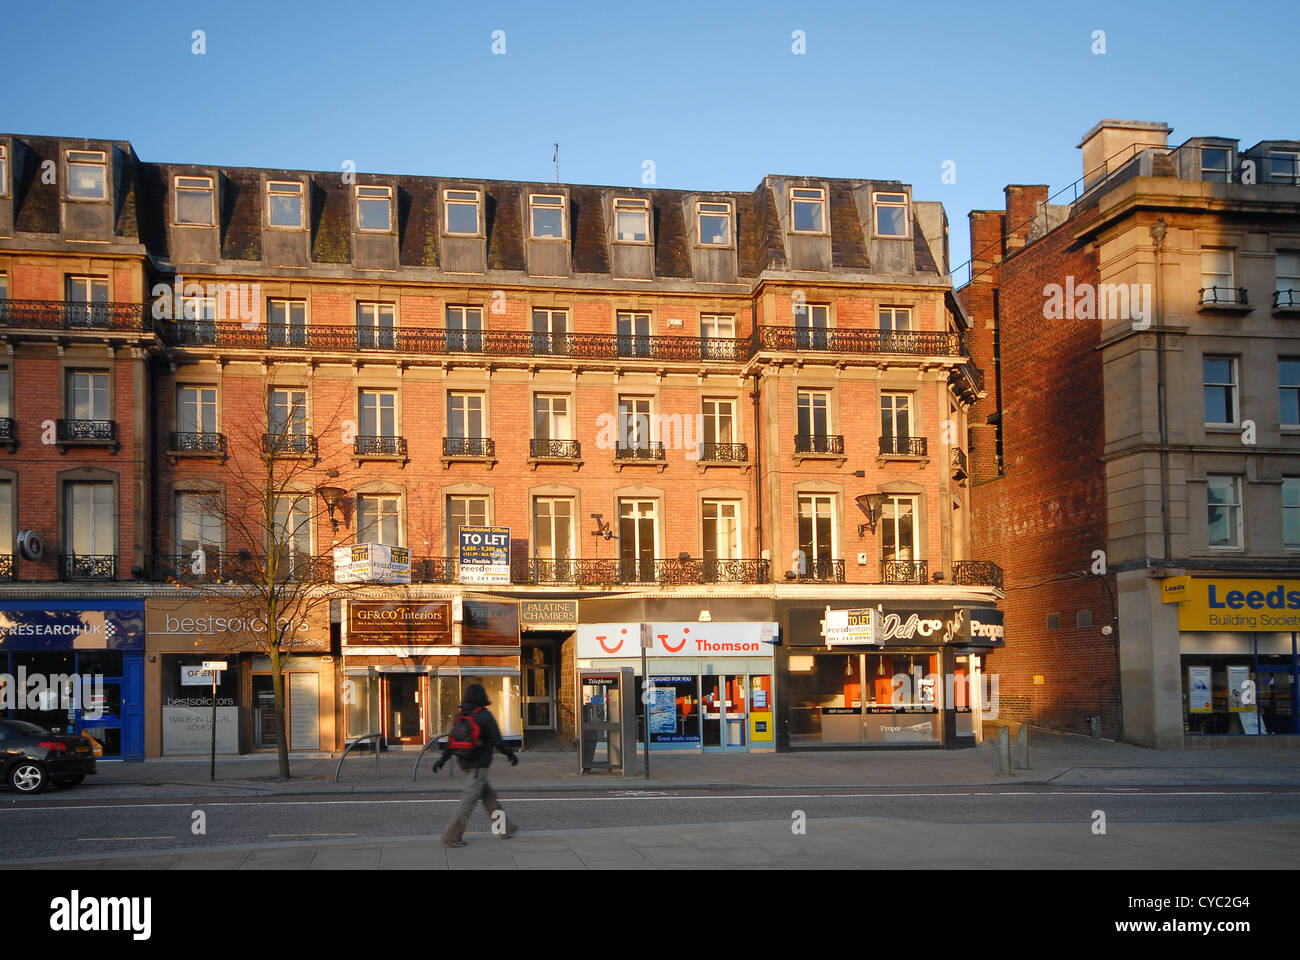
1162, 578, 1300, 632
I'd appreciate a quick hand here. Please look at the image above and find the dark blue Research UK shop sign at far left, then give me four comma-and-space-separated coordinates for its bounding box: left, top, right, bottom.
0, 600, 144, 653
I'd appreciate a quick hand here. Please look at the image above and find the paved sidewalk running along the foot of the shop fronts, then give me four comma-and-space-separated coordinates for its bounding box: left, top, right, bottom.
61, 731, 1300, 799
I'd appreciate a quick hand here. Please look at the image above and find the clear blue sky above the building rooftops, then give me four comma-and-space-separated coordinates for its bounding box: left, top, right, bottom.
0, 0, 1300, 264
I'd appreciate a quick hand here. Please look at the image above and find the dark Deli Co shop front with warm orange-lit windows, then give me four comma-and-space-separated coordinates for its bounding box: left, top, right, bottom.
781, 605, 1002, 749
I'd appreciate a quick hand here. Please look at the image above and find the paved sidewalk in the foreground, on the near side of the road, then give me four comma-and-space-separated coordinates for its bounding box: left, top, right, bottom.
10, 818, 1300, 870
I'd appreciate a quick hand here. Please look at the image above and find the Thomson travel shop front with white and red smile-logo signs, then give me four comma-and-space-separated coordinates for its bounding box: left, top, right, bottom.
577, 622, 779, 753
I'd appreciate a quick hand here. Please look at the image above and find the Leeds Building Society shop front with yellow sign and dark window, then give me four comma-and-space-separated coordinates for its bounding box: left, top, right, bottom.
1161, 576, 1300, 739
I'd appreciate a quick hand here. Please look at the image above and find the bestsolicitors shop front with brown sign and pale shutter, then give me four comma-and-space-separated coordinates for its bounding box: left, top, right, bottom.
146, 598, 337, 757
